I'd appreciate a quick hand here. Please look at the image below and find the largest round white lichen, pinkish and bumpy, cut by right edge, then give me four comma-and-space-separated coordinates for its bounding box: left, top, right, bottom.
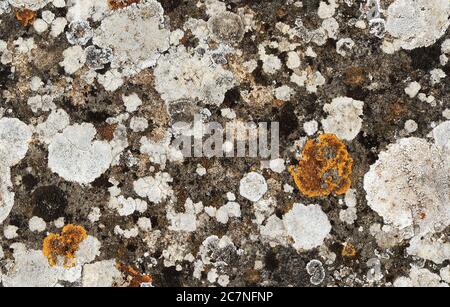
364, 138, 450, 239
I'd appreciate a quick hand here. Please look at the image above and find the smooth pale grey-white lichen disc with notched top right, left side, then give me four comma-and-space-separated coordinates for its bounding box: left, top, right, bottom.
48, 123, 112, 184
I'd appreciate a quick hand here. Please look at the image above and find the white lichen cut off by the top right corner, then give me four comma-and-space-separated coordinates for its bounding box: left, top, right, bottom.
386, 0, 450, 50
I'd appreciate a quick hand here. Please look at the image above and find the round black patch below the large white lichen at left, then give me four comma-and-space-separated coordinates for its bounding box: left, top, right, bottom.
31, 185, 67, 222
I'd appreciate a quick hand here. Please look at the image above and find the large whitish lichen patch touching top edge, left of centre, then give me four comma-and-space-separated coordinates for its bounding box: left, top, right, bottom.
93, 0, 170, 76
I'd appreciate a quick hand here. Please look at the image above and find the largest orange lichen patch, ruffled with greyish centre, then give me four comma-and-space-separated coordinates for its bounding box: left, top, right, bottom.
289, 134, 353, 197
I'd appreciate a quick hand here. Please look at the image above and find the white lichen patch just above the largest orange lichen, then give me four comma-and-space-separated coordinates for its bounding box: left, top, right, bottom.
322, 97, 364, 141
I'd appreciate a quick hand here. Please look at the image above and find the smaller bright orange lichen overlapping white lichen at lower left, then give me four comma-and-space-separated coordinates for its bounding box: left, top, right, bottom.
42, 224, 87, 267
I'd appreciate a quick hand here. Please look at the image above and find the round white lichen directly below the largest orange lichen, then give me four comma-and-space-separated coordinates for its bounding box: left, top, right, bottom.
283, 204, 331, 250
